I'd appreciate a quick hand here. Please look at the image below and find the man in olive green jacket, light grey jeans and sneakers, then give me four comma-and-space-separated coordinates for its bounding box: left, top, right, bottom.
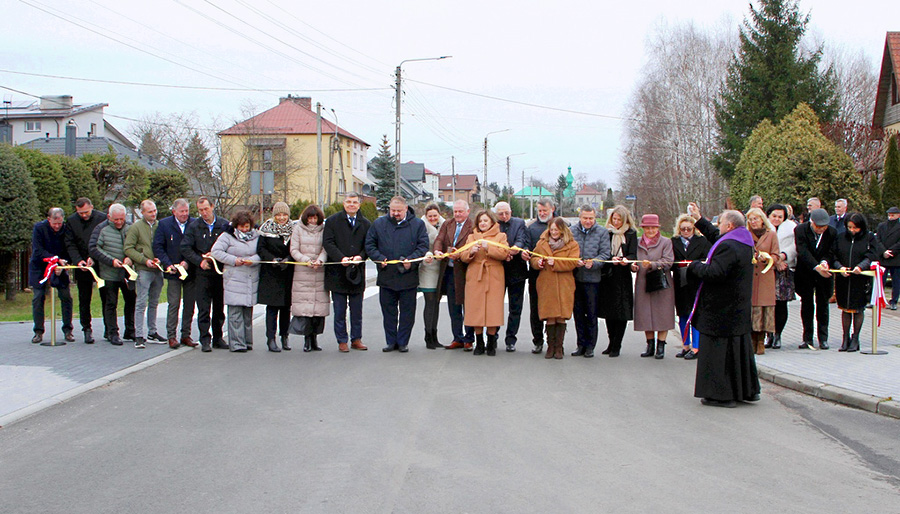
125, 200, 166, 348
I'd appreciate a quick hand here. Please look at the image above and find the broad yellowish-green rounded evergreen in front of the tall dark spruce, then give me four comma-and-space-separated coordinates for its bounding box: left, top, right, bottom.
731, 104, 870, 212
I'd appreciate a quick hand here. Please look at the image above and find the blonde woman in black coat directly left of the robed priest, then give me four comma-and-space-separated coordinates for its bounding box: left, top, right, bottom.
672, 214, 712, 360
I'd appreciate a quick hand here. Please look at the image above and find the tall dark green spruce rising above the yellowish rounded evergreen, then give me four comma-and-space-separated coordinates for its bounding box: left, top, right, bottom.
712, 0, 838, 180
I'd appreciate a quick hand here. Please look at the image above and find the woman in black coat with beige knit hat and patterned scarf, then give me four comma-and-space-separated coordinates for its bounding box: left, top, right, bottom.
256, 202, 294, 352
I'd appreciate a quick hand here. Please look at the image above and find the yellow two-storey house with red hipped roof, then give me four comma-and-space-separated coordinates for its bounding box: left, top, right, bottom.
219, 95, 369, 205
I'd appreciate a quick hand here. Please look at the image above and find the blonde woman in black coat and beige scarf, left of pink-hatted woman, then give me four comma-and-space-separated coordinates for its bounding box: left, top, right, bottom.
598, 205, 637, 357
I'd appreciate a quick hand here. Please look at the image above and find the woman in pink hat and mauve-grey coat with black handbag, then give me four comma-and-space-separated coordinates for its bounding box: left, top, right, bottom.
631, 214, 675, 359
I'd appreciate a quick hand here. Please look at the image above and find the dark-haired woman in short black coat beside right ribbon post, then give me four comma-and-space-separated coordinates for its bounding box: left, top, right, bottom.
831, 213, 876, 352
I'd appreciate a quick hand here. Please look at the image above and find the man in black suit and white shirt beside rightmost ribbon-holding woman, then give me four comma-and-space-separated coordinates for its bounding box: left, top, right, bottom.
794, 209, 837, 350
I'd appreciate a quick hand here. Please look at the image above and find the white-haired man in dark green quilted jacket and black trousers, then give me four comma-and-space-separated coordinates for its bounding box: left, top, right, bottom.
89, 203, 135, 346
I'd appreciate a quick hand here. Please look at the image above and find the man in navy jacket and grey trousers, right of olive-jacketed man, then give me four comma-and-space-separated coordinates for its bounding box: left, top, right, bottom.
153, 198, 197, 348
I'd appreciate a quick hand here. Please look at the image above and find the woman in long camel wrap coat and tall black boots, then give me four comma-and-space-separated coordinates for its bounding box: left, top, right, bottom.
460, 211, 509, 355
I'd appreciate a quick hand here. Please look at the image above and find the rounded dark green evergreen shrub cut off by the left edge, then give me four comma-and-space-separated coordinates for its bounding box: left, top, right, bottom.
0, 144, 40, 300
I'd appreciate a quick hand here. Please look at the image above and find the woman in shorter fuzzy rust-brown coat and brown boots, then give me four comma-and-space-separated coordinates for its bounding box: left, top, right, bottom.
531, 217, 581, 359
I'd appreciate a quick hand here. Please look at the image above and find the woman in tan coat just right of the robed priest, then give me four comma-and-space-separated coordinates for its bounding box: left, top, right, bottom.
747, 208, 781, 355
